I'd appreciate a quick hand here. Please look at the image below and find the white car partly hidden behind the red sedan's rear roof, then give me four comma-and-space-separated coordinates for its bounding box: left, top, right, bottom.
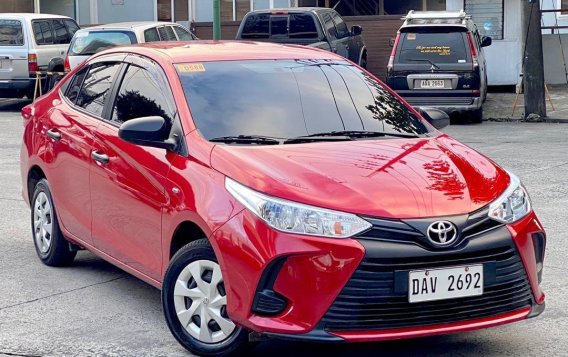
65, 21, 197, 70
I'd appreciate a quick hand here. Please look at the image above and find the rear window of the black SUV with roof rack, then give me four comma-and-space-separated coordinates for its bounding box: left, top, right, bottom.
397, 32, 468, 64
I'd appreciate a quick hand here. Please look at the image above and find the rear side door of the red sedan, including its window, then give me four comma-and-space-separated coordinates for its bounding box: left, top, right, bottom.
40, 57, 122, 243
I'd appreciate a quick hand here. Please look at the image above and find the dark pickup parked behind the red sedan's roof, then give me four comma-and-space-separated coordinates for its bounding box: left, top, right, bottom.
236, 7, 367, 68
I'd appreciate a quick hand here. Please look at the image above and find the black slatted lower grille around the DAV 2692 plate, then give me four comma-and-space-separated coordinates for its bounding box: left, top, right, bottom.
322, 228, 532, 331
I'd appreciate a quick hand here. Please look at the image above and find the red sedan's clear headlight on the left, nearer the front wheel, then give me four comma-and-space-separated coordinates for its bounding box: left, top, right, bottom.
225, 178, 371, 238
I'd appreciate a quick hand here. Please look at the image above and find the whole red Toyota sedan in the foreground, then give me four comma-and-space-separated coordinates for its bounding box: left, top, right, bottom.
21, 42, 546, 355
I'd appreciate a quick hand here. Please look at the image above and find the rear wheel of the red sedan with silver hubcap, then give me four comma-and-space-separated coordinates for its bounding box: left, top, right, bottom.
31, 179, 77, 267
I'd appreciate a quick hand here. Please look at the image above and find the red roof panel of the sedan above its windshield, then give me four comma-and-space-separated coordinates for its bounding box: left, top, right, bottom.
97, 40, 345, 63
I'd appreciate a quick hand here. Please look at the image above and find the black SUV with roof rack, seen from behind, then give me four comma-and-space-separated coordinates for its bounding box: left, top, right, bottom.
387, 11, 491, 123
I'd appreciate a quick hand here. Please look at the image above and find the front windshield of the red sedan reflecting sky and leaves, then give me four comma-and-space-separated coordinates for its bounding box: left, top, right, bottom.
177, 60, 428, 139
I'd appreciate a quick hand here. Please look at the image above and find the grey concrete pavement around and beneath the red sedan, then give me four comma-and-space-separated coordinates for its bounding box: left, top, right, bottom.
0, 100, 568, 357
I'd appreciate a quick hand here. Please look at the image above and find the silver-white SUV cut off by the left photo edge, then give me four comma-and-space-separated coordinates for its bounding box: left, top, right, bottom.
0, 13, 79, 98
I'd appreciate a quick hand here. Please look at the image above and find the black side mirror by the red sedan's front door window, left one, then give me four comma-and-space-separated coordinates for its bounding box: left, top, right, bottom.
118, 116, 176, 150
